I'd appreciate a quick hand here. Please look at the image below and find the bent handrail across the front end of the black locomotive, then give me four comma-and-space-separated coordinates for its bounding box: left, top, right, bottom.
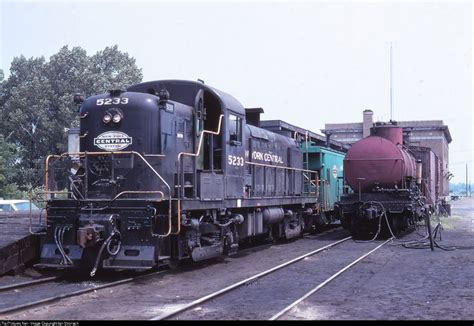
45, 151, 173, 237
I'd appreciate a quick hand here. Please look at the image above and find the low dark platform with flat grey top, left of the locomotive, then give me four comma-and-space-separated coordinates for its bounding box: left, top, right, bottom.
0, 212, 43, 275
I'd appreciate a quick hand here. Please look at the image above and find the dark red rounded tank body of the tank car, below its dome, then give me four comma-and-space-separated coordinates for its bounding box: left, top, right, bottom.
344, 136, 416, 192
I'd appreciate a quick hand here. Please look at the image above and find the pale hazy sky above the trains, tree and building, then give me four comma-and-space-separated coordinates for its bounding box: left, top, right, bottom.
0, 0, 474, 182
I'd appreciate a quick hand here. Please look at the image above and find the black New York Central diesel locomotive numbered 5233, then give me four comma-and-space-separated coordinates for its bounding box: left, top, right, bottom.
39, 80, 318, 275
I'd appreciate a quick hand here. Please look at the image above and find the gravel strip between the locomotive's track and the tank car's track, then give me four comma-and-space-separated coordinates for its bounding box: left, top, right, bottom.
0, 229, 349, 320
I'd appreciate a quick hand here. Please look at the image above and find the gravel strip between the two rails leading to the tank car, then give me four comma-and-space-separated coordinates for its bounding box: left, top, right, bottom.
173, 240, 382, 320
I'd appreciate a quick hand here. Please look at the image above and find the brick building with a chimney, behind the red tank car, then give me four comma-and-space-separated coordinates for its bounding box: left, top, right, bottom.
322, 110, 452, 196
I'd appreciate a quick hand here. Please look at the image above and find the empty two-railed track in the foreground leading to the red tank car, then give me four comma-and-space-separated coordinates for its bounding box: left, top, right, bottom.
151, 237, 392, 320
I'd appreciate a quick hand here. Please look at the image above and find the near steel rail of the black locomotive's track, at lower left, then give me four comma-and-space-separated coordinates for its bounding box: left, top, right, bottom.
0, 270, 169, 315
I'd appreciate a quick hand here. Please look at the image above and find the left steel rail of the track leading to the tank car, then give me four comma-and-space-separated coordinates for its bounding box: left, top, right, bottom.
151, 237, 352, 320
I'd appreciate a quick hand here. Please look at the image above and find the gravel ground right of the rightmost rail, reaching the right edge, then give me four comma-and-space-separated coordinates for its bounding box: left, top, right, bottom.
284, 199, 474, 320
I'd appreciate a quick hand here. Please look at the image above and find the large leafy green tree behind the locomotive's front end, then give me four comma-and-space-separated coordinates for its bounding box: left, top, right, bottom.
0, 46, 142, 193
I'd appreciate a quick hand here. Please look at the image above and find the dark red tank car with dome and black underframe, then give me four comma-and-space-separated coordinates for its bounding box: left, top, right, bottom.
337, 123, 431, 238
